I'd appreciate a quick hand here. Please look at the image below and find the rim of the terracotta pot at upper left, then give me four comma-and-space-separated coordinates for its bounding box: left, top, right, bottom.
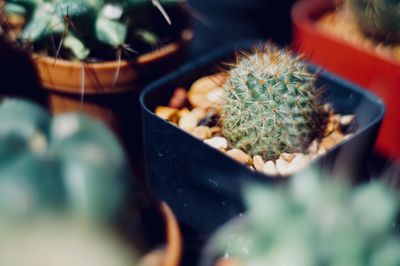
32, 28, 193, 70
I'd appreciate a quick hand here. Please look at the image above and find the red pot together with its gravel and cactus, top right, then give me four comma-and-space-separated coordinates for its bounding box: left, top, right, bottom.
292, 0, 400, 159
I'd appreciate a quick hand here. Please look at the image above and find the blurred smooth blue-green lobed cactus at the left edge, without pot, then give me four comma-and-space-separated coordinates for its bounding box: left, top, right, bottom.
0, 100, 132, 223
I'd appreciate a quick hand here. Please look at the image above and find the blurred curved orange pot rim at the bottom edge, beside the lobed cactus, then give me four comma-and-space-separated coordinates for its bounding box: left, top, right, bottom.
160, 202, 182, 266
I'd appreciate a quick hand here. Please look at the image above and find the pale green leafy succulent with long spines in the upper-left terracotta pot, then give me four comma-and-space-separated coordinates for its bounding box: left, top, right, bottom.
5, 0, 182, 60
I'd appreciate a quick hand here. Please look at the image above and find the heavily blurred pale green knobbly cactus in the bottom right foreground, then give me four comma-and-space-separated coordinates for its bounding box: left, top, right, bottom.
201, 171, 400, 266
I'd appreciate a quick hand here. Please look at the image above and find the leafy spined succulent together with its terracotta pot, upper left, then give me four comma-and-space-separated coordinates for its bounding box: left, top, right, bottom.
4, 0, 190, 178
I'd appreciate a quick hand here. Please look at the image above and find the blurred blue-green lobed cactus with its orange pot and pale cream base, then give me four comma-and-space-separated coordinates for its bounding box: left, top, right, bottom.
0, 99, 181, 266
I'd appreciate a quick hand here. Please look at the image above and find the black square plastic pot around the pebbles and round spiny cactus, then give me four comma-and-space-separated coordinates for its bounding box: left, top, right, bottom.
140, 42, 385, 245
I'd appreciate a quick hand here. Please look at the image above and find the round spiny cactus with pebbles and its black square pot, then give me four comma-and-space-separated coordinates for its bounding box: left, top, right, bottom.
141, 42, 384, 262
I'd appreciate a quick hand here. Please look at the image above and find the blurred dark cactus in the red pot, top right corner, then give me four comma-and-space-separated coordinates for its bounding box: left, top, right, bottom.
346, 0, 400, 43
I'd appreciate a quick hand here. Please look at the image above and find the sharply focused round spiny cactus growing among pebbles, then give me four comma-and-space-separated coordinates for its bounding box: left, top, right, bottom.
221, 44, 322, 160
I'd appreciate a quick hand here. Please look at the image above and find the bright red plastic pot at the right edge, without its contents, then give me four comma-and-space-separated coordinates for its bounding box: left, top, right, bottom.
292, 0, 400, 159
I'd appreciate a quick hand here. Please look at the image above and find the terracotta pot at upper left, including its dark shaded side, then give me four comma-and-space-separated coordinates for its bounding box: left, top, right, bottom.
34, 30, 192, 178
